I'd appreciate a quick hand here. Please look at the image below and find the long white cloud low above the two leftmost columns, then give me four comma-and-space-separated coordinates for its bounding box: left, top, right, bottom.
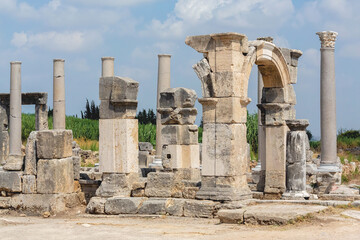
11, 31, 102, 52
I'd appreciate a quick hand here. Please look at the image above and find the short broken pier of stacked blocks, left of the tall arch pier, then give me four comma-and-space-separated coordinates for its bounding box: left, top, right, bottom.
157, 88, 200, 171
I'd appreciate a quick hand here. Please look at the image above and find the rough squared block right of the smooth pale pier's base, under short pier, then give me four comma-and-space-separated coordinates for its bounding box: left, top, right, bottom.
145, 172, 174, 197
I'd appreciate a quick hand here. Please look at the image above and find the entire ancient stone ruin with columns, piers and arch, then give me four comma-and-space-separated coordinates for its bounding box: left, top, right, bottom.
0, 32, 360, 222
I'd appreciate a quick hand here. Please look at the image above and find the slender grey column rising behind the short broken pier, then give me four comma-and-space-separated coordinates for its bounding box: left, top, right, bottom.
153, 54, 171, 166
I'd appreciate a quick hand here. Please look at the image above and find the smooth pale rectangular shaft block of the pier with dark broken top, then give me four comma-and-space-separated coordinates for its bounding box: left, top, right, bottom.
99, 119, 139, 173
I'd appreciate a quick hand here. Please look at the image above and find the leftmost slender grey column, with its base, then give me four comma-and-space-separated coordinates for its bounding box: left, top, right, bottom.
4, 62, 23, 170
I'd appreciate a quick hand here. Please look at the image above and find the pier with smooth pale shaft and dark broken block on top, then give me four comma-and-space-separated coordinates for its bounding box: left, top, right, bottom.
97, 56, 139, 197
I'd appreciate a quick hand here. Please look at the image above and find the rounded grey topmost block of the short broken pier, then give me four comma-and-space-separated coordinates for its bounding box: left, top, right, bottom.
159, 87, 197, 109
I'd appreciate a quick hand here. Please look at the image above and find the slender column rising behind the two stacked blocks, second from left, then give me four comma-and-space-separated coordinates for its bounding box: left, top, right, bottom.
53, 59, 65, 130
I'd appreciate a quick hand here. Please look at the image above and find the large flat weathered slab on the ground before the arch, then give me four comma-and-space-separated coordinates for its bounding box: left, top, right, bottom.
244, 204, 327, 225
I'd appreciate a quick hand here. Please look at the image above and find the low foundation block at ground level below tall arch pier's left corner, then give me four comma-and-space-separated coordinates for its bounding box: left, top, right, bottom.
184, 200, 218, 218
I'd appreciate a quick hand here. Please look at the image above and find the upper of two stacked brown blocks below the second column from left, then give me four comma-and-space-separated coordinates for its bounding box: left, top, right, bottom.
36, 130, 73, 159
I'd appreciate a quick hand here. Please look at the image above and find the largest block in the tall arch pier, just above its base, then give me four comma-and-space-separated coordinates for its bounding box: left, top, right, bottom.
202, 123, 247, 178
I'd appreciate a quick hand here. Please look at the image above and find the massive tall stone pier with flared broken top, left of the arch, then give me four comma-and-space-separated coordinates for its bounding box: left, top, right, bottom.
185, 33, 251, 201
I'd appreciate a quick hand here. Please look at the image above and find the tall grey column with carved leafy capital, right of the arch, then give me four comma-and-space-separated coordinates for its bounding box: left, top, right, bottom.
316, 31, 340, 172
